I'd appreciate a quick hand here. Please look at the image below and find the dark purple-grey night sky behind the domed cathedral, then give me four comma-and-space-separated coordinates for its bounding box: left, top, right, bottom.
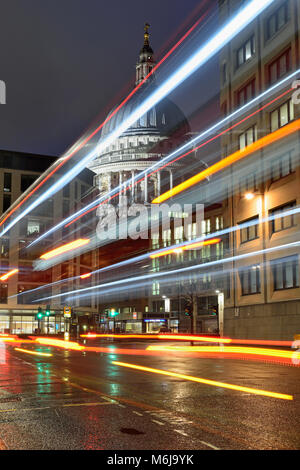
0, 0, 219, 156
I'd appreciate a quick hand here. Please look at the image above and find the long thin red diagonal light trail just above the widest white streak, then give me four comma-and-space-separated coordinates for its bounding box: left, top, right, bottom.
0, 7, 211, 231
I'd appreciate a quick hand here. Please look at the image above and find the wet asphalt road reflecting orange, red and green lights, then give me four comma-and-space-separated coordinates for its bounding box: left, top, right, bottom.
0, 342, 300, 450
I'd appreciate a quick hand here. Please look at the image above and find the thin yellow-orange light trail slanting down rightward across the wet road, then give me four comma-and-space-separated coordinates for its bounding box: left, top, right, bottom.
112, 361, 293, 400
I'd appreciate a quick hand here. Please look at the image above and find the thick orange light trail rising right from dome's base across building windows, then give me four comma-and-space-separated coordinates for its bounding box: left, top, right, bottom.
152, 119, 300, 204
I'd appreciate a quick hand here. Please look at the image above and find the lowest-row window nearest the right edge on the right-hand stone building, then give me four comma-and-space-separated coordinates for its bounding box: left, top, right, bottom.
271, 256, 299, 290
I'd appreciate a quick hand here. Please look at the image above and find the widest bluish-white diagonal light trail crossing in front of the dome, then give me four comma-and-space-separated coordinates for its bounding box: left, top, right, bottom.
0, 0, 274, 242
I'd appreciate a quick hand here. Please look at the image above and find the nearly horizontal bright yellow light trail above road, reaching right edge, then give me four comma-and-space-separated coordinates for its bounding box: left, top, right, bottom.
146, 345, 300, 359
